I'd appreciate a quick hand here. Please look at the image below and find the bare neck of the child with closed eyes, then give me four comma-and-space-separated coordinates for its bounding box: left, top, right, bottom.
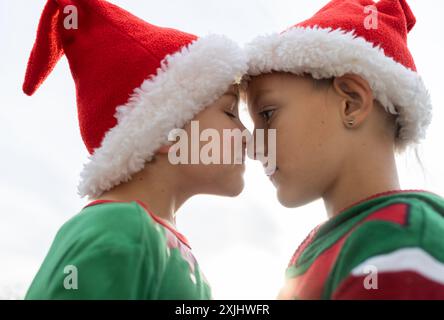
96, 158, 191, 226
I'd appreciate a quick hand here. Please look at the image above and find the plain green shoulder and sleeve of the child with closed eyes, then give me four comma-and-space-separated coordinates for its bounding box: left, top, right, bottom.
27, 202, 171, 299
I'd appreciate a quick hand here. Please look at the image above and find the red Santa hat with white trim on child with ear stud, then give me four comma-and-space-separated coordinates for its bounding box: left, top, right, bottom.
246, 0, 432, 151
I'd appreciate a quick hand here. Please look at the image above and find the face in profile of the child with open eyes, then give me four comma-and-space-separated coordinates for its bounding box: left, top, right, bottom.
246, 72, 347, 207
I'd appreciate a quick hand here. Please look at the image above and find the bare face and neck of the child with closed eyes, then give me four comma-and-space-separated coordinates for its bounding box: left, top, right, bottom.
92, 85, 245, 225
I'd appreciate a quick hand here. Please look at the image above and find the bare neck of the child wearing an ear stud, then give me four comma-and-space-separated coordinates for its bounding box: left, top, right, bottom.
322, 142, 400, 218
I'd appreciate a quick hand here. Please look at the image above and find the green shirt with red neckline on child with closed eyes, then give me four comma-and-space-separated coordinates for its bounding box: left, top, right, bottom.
25, 200, 211, 300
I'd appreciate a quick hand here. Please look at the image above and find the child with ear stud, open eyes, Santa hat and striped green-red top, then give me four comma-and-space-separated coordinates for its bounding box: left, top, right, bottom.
246, 0, 444, 299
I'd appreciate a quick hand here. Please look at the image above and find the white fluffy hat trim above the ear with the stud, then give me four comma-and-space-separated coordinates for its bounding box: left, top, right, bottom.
246, 27, 432, 151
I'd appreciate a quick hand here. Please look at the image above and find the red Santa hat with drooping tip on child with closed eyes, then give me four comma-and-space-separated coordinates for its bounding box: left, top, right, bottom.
23, 0, 247, 197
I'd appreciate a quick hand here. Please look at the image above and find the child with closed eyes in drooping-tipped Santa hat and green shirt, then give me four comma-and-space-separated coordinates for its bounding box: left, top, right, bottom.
23, 0, 247, 299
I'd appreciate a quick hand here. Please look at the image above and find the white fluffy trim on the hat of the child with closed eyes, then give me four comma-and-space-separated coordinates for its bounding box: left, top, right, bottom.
78, 35, 247, 198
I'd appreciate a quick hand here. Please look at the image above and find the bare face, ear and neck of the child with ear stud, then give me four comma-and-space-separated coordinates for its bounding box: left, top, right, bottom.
246, 72, 399, 218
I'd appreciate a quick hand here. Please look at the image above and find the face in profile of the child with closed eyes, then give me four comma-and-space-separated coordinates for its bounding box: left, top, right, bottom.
170, 85, 246, 196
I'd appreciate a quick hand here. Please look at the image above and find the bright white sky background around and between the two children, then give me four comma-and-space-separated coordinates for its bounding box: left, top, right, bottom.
0, 0, 444, 299
